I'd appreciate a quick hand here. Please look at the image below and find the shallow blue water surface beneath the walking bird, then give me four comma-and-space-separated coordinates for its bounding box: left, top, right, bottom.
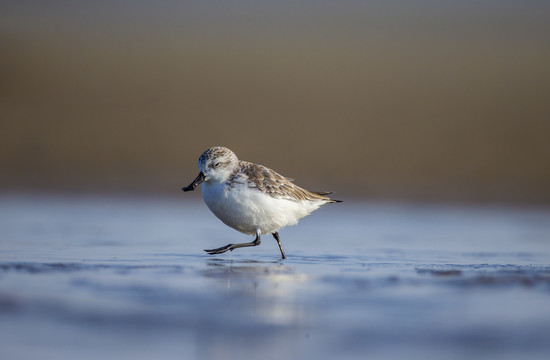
0, 195, 550, 359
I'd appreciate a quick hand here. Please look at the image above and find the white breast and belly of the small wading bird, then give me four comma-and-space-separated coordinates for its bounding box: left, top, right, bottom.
202, 183, 324, 234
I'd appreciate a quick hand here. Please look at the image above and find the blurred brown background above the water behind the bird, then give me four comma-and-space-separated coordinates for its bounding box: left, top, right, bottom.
0, 0, 550, 203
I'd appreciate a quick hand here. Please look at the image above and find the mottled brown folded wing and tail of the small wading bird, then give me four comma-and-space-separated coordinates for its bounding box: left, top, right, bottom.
240, 161, 337, 202
